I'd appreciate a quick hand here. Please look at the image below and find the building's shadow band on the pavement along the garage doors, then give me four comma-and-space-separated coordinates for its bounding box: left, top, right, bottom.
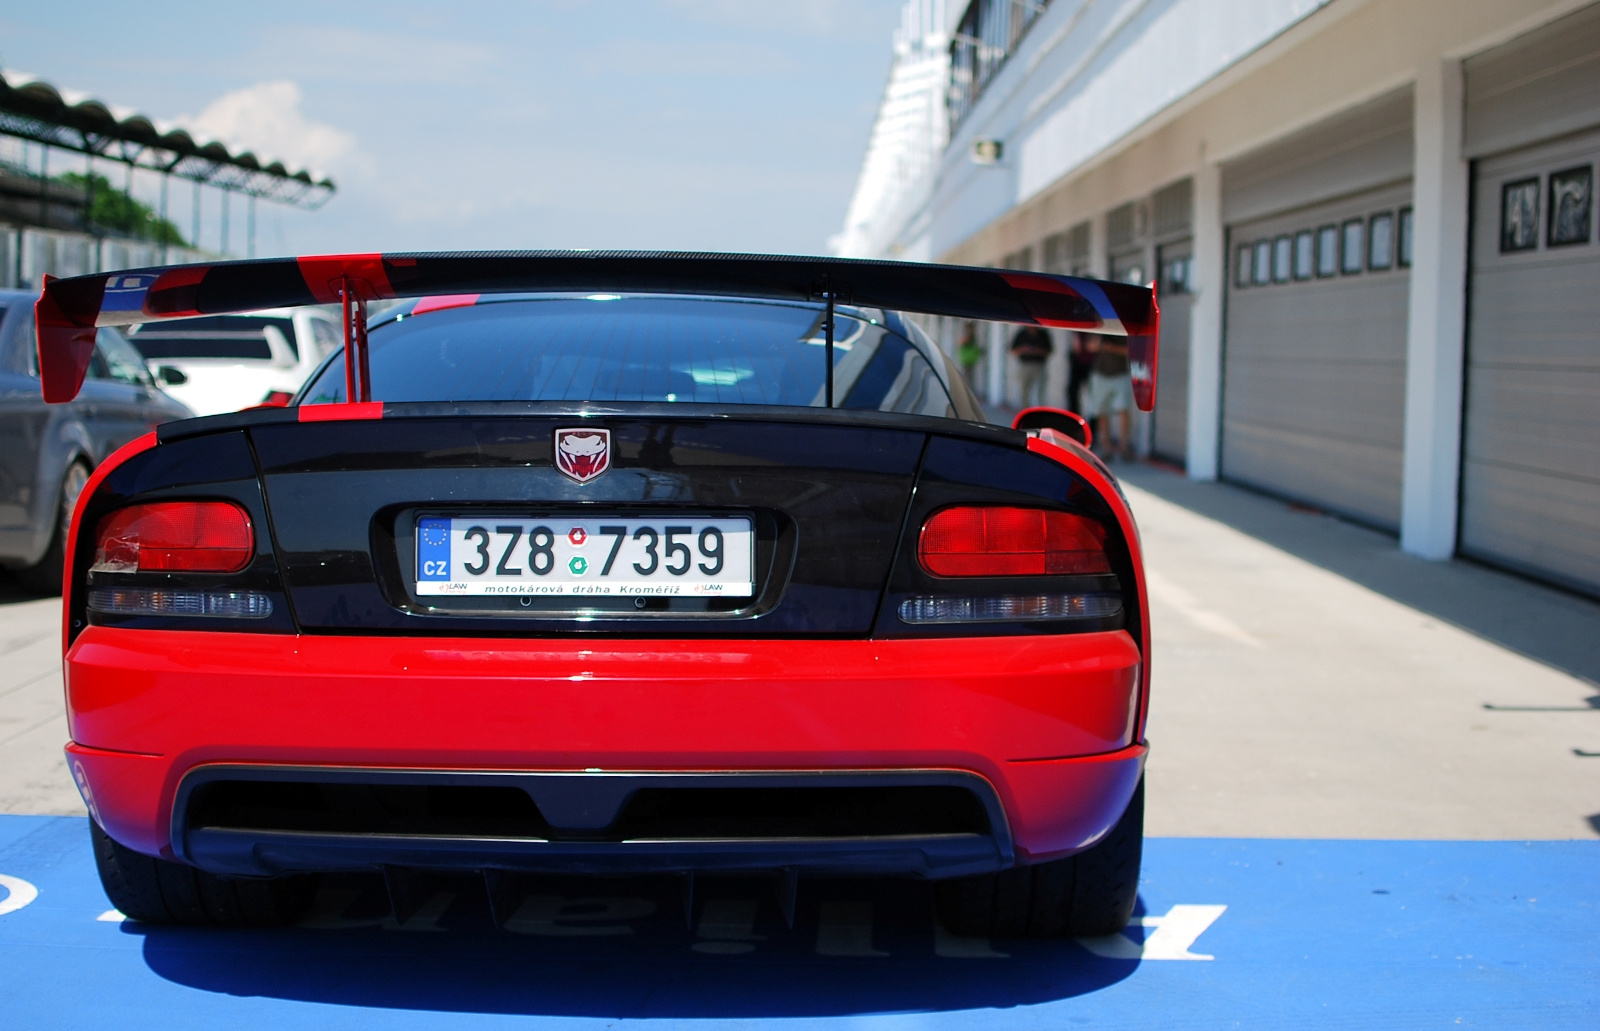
1117, 464, 1600, 688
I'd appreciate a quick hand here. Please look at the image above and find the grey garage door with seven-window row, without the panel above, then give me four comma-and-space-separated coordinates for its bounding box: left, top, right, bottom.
1222, 186, 1411, 528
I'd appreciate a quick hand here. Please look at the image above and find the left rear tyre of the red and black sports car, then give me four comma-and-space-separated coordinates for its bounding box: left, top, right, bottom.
90, 820, 317, 927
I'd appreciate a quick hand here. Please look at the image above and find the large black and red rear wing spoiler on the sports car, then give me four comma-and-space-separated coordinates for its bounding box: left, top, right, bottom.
34, 251, 1160, 411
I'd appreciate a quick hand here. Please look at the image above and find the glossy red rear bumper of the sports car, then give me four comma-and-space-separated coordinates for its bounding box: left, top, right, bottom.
67, 628, 1146, 861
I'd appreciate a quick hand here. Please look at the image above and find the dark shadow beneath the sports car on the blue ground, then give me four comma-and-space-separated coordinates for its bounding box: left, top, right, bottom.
123, 876, 1141, 1018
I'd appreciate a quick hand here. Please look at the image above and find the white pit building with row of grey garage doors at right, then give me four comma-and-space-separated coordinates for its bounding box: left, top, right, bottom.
835, 0, 1600, 594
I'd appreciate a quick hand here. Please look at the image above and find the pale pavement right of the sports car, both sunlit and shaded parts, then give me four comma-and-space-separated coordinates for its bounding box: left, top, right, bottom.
1117, 466, 1600, 839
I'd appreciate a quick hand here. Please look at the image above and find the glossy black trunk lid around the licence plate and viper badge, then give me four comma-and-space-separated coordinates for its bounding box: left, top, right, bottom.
250, 415, 926, 636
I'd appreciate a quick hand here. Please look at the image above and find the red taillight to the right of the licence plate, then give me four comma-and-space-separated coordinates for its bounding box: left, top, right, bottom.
917, 506, 1110, 576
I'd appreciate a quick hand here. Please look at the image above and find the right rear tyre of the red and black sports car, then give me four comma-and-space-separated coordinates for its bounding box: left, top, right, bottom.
938, 776, 1144, 938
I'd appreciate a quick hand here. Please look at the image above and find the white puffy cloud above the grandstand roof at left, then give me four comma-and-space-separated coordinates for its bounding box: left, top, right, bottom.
178, 78, 355, 173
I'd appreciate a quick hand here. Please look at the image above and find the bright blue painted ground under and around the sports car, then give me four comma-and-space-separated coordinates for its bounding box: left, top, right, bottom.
0, 816, 1600, 1031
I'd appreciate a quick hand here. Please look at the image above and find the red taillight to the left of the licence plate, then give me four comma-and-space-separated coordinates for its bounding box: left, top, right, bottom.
90, 501, 256, 573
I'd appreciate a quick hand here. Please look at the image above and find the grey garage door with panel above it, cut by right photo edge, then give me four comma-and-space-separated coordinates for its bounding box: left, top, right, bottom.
1461, 10, 1600, 592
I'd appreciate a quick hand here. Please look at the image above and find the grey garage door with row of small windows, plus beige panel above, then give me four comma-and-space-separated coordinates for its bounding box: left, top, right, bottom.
1222, 88, 1413, 530
